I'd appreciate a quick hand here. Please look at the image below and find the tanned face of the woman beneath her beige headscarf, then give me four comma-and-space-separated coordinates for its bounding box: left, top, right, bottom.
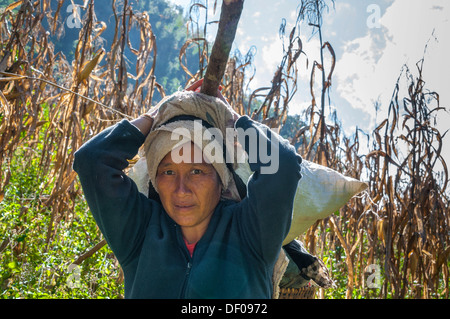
156, 143, 222, 229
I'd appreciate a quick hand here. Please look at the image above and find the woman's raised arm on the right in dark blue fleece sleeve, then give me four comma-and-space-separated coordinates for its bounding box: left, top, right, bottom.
236, 116, 302, 260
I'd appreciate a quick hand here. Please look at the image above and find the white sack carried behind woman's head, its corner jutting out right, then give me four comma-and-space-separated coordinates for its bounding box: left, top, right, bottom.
128, 157, 368, 245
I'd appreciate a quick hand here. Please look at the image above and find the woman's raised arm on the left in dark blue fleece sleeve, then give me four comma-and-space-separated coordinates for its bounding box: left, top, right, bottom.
73, 119, 152, 263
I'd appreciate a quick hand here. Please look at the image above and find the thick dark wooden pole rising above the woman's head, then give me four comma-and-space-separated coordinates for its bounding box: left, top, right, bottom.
200, 0, 244, 96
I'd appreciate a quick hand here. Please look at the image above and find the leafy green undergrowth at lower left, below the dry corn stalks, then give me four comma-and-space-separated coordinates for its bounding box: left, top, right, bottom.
0, 110, 123, 299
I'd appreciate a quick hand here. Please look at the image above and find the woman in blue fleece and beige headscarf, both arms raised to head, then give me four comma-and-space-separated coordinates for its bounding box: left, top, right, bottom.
74, 82, 301, 298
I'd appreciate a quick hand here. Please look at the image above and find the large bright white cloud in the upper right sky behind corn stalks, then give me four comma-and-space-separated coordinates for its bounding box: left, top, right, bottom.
335, 0, 450, 169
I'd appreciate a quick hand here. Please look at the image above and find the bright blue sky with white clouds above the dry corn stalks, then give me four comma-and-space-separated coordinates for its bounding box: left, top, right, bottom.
171, 0, 450, 175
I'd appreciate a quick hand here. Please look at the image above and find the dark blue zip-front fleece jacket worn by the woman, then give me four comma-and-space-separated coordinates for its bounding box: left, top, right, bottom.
74, 116, 301, 299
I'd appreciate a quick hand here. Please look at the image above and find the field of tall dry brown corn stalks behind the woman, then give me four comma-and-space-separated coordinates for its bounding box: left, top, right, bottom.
0, 0, 450, 299
